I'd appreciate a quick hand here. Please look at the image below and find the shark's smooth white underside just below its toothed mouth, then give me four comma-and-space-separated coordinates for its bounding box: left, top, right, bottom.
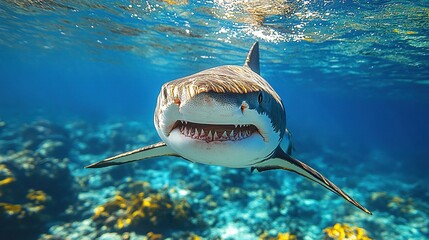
165, 129, 272, 168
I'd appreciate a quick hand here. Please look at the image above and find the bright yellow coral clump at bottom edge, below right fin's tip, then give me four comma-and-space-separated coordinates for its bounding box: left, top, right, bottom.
323, 223, 371, 240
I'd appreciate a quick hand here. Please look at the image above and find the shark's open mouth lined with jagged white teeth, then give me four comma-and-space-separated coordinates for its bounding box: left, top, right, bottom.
173, 121, 259, 142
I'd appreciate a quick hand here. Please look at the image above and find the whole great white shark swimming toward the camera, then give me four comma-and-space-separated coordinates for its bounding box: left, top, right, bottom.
86, 42, 372, 214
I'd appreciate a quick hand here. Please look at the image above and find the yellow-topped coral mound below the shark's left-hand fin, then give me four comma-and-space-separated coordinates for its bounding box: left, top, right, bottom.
92, 182, 203, 234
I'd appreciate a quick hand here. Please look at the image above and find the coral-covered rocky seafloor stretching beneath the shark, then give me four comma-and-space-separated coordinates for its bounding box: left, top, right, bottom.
0, 120, 429, 239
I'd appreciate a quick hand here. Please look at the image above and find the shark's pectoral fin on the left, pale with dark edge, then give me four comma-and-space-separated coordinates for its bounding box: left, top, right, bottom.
85, 142, 178, 168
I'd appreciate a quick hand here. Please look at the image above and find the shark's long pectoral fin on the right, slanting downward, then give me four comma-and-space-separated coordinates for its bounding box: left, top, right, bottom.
252, 148, 372, 215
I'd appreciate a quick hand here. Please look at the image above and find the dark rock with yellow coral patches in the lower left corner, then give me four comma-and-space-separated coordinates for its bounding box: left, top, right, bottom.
0, 150, 76, 239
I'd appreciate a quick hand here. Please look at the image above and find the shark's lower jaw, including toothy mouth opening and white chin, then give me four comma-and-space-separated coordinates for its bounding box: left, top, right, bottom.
157, 120, 274, 168
